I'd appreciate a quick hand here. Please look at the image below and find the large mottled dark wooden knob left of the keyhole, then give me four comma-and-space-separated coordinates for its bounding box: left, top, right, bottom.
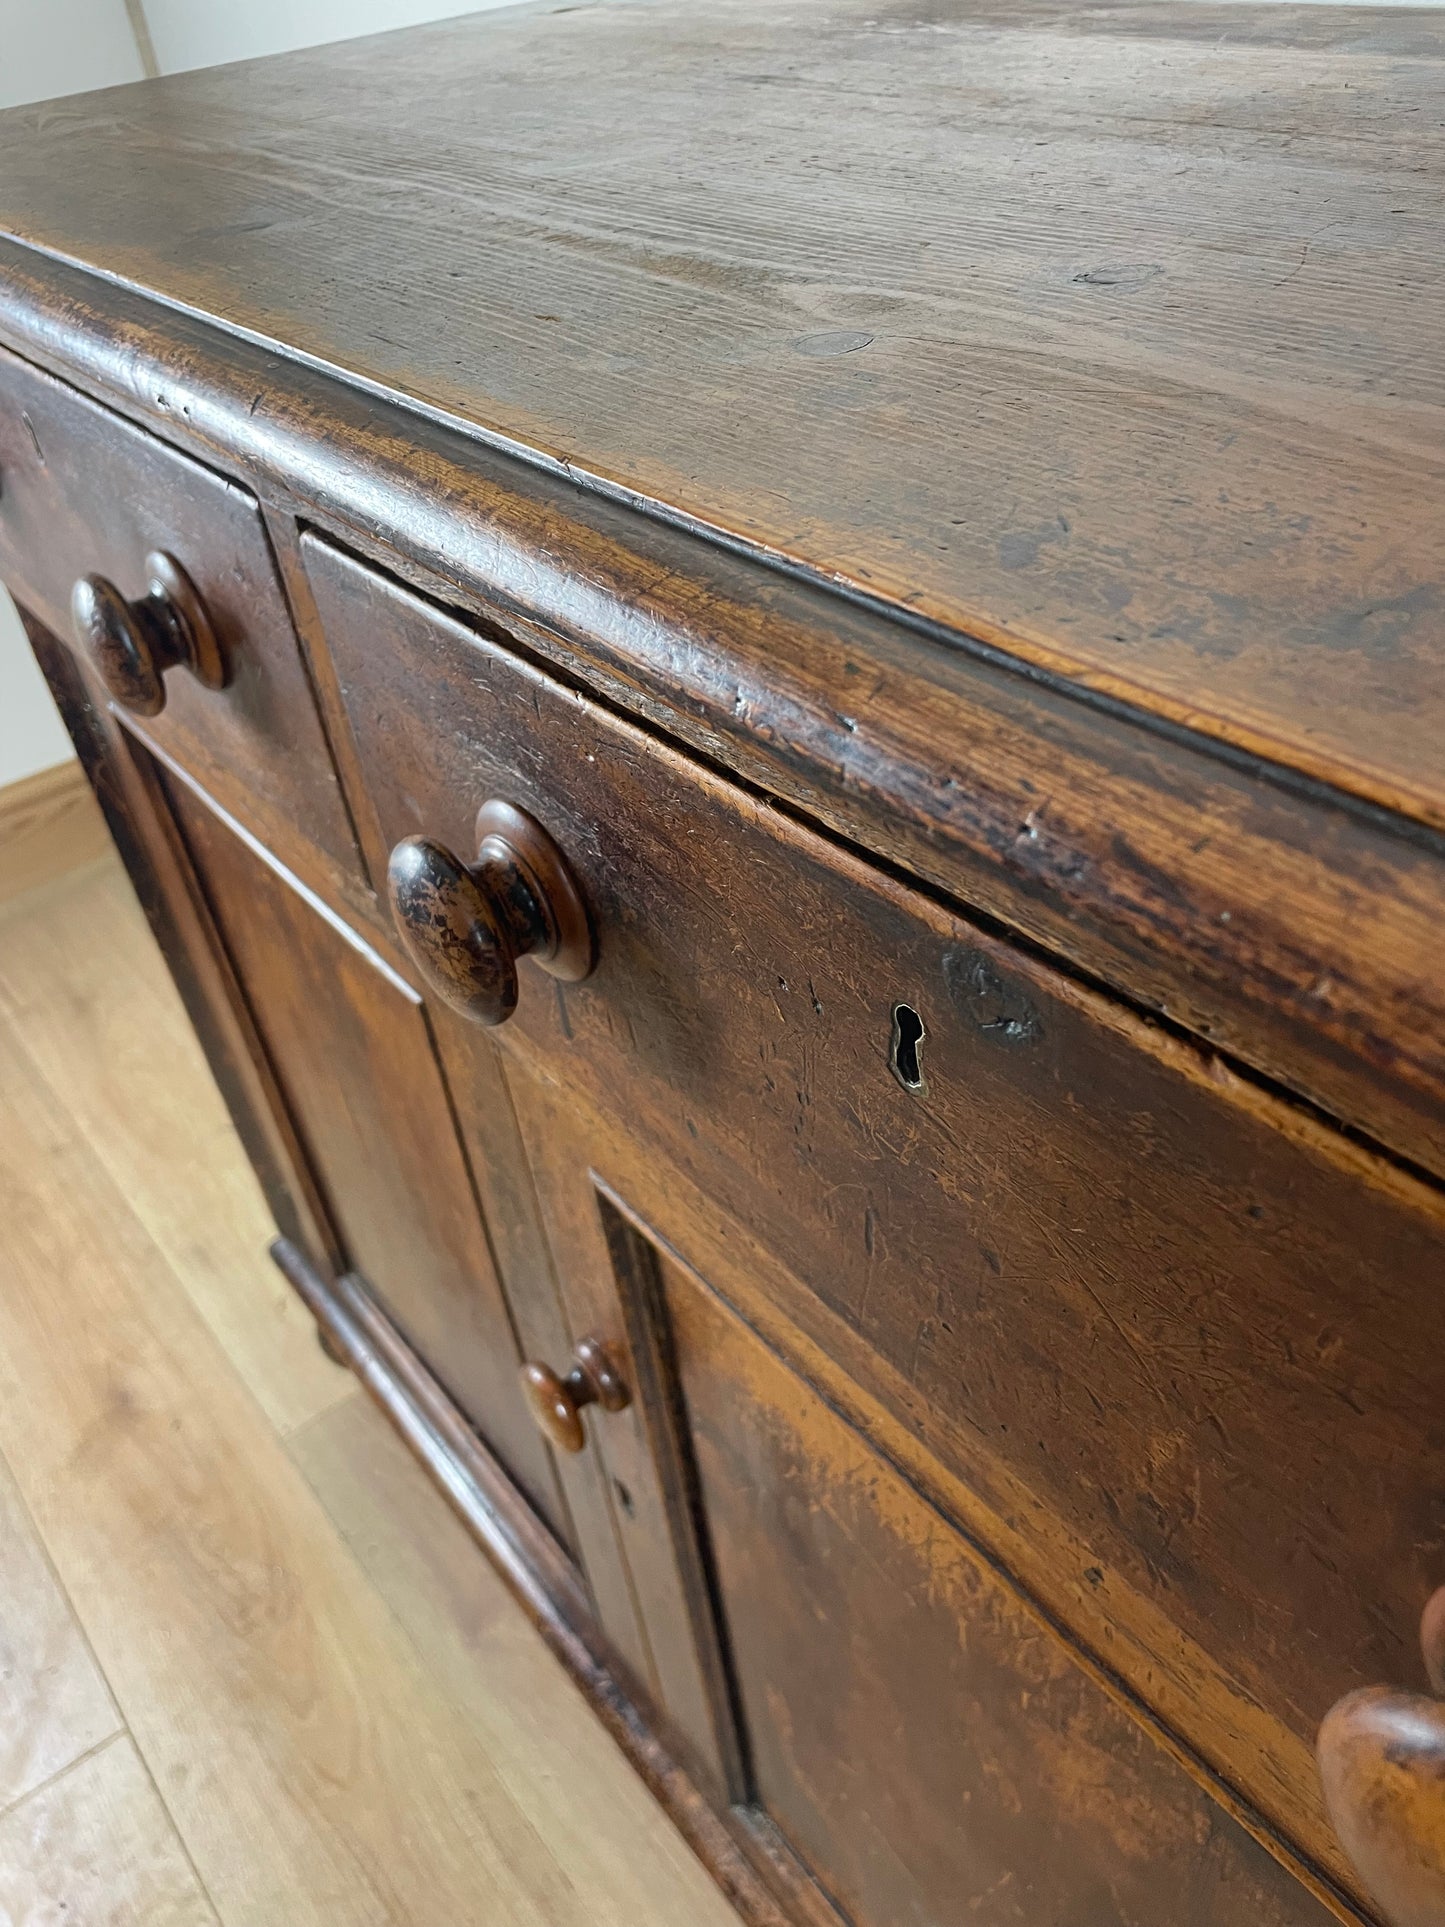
387, 802, 593, 1025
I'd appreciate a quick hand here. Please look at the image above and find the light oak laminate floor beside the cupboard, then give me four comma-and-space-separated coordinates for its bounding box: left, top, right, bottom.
0, 858, 734, 1927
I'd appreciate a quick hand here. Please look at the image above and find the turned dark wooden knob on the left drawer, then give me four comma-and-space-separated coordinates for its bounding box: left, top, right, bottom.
69, 553, 225, 717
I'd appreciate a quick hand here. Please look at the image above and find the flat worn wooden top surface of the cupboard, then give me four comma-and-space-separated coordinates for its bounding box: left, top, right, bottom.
0, 0, 1445, 825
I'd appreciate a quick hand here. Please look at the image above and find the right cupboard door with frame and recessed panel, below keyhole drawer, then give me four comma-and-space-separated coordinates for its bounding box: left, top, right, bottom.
509, 1050, 1331, 1927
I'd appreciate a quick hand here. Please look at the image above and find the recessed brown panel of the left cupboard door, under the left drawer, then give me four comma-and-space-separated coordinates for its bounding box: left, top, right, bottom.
164, 777, 566, 1536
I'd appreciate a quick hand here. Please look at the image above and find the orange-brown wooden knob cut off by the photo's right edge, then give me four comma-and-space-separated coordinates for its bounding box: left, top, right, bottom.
1318, 1586, 1445, 1927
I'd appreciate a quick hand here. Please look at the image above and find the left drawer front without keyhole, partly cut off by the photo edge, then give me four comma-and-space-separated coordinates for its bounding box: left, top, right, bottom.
0, 351, 364, 896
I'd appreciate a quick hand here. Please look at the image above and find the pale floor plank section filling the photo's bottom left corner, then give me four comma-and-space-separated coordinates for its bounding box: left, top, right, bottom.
0, 1736, 218, 1927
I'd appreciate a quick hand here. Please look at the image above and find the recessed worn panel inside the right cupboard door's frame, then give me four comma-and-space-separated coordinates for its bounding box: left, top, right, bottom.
657, 1253, 1327, 1927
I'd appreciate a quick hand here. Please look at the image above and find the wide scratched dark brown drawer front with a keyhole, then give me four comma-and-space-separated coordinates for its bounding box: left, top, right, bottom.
306, 540, 1445, 1838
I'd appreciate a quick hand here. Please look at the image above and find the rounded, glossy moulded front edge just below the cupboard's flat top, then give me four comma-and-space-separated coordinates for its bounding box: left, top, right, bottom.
0, 241, 1445, 1172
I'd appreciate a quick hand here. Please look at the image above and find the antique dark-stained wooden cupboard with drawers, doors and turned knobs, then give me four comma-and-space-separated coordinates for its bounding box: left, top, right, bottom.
0, 0, 1445, 1927
